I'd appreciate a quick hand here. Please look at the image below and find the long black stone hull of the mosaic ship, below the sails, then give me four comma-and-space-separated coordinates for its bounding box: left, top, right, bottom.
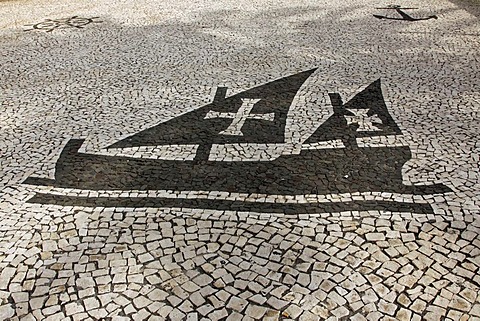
25, 140, 450, 195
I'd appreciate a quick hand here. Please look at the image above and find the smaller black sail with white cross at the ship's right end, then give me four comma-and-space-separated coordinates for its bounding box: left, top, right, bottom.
305, 79, 401, 146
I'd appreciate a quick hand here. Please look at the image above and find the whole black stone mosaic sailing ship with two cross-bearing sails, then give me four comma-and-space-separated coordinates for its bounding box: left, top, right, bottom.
24, 69, 451, 214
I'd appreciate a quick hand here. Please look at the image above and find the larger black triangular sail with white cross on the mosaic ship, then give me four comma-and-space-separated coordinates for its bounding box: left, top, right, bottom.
108, 69, 316, 149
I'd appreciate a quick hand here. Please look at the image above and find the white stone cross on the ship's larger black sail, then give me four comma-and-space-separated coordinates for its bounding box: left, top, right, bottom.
205, 98, 275, 136
